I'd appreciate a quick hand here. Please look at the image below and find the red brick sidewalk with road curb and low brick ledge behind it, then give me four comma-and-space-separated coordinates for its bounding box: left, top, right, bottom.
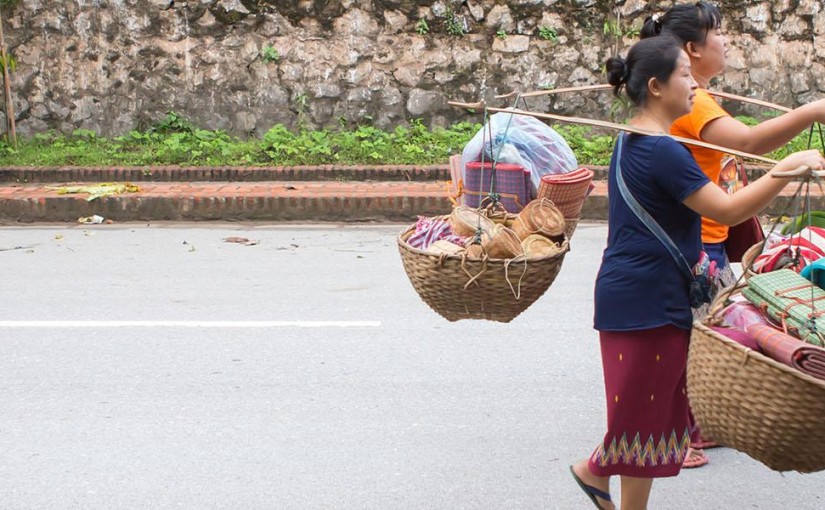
0, 161, 808, 222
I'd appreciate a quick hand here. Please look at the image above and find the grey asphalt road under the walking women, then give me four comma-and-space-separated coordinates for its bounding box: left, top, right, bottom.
0, 224, 825, 509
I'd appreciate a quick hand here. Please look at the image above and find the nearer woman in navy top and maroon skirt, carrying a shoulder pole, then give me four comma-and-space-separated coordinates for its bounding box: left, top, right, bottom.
570, 37, 825, 510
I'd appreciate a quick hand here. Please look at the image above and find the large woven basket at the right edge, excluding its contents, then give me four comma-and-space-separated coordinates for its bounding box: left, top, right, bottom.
687, 322, 825, 473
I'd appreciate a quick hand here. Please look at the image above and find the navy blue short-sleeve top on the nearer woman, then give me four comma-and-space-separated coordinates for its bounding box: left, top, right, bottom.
594, 134, 710, 331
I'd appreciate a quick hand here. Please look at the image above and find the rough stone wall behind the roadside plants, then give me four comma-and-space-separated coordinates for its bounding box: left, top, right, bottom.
3, 0, 825, 135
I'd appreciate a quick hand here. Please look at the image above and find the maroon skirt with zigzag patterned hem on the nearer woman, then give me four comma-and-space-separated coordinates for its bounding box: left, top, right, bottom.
588, 325, 692, 478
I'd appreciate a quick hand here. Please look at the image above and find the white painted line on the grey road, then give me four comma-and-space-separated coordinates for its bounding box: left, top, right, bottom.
0, 321, 381, 329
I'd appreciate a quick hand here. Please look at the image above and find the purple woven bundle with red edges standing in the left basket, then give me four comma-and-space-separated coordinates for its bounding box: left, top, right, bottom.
463, 161, 530, 213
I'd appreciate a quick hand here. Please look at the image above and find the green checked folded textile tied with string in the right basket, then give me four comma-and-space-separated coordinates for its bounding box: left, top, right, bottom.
742, 269, 825, 346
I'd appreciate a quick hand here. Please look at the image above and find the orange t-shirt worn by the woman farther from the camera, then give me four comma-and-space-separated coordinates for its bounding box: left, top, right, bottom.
670, 89, 730, 243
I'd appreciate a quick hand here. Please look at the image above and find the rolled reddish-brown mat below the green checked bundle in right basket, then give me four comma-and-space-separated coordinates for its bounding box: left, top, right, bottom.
748, 324, 825, 379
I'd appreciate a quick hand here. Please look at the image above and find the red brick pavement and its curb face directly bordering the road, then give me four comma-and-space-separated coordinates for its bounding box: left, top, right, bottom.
0, 181, 825, 222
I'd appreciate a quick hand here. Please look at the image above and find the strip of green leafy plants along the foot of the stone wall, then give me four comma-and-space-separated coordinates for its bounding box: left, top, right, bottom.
0, 115, 822, 166
